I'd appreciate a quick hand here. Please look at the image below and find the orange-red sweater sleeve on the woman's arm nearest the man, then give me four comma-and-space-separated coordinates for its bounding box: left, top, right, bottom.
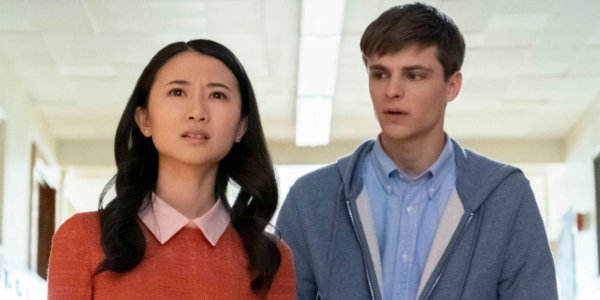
267, 241, 296, 300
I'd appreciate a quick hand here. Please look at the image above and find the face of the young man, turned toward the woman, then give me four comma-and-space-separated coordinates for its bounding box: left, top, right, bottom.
366, 46, 462, 144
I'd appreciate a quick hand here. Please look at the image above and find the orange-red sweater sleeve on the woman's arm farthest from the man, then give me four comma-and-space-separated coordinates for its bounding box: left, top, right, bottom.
48, 214, 93, 300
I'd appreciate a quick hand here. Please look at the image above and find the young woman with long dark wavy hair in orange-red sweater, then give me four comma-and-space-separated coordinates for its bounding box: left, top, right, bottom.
48, 40, 296, 299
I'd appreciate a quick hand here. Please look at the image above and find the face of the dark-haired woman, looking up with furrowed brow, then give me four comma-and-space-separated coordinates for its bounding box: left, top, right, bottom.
136, 51, 246, 167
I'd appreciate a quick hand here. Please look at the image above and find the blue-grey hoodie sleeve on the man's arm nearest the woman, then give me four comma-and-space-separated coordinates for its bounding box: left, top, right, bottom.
277, 187, 317, 300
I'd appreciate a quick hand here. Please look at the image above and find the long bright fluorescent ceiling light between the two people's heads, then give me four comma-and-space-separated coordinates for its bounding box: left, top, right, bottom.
296, 0, 345, 146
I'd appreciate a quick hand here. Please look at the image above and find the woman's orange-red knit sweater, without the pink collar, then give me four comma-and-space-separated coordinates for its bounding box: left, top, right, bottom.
48, 212, 296, 300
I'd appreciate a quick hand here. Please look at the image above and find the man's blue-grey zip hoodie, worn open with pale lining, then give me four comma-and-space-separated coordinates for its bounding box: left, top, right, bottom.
277, 140, 558, 300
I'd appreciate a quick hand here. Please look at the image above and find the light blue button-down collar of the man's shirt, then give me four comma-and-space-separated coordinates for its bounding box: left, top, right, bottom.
372, 136, 454, 198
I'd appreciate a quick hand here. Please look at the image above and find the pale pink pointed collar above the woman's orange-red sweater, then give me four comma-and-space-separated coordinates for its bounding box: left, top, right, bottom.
138, 193, 231, 246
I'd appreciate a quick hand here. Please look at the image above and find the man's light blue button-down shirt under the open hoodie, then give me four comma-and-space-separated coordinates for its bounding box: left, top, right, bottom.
362, 138, 456, 300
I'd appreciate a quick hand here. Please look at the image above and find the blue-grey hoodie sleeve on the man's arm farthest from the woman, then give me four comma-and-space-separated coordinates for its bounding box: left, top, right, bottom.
498, 179, 558, 299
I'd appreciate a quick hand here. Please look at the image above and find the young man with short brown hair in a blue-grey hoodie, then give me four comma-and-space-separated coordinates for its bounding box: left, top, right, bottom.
278, 3, 557, 299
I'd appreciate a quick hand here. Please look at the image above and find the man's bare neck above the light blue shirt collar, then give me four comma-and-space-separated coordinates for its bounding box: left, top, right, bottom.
379, 132, 446, 177
